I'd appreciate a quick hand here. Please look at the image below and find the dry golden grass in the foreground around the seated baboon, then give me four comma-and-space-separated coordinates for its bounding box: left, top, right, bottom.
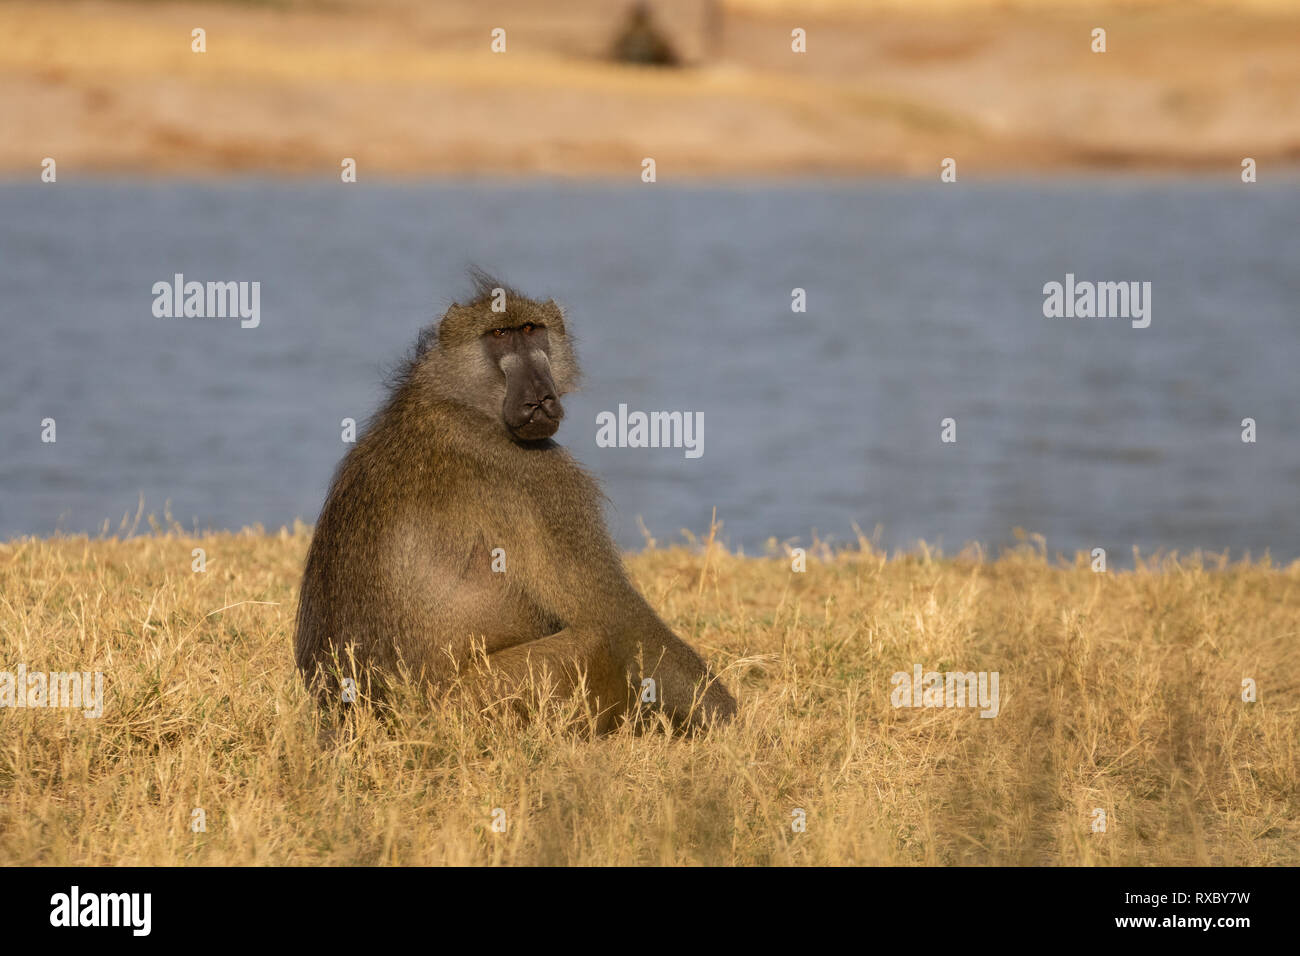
0, 527, 1300, 865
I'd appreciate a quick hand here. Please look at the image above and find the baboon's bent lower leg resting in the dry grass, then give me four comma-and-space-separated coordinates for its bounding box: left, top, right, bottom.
482, 627, 628, 734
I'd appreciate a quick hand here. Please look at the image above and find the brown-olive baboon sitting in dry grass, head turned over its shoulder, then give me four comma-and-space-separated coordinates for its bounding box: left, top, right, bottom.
295, 272, 736, 732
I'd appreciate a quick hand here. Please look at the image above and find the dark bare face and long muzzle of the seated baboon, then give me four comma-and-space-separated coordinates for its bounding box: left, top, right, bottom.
482, 321, 564, 441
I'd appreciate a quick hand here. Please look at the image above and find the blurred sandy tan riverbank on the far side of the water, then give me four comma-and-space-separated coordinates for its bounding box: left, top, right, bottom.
0, 0, 1300, 181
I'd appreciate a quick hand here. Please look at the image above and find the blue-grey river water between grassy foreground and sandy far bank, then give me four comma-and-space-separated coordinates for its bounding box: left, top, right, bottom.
0, 178, 1300, 561
